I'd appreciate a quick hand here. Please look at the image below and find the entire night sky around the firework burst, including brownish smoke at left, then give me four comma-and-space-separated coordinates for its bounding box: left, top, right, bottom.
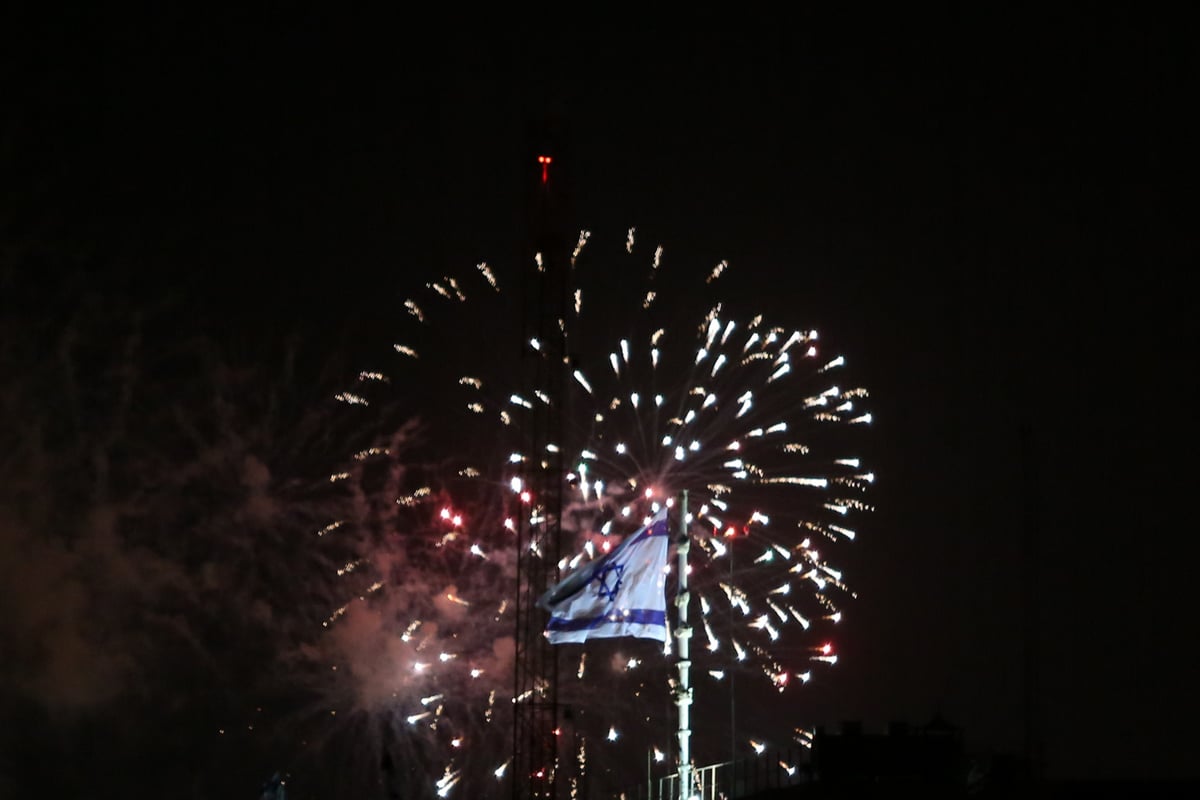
0, 4, 1200, 798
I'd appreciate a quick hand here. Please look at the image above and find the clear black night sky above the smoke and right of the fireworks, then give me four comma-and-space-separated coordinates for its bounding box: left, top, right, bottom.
0, 8, 1200, 796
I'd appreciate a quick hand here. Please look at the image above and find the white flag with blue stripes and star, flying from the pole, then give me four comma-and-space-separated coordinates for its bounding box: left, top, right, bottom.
538, 509, 671, 644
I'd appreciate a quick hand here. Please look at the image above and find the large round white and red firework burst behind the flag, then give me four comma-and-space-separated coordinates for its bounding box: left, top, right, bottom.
323, 230, 874, 795
